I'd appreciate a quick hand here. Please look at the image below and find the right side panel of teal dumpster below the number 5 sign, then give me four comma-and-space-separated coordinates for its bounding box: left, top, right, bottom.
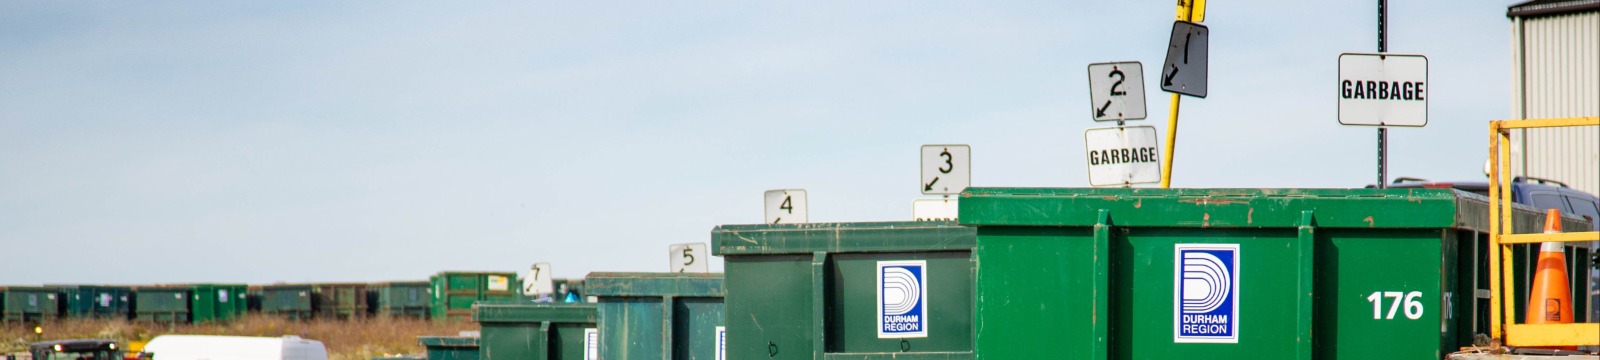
672, 298, 725, 360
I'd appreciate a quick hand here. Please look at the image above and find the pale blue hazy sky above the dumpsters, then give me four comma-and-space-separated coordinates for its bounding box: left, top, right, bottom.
0, 0, 1510, 285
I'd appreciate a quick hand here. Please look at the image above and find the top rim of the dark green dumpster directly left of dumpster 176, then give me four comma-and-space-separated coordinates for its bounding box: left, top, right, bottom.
710, 221, 978, 256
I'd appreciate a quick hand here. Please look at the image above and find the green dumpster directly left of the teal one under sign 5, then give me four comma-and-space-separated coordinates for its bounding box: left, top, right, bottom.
472, 302, 598, 360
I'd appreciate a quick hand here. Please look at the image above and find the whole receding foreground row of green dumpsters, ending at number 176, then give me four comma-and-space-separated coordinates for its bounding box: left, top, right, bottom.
422, 189, 1594, 360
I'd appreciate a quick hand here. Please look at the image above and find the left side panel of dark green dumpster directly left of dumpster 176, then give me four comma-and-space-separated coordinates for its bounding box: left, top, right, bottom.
723, 254, 818, 358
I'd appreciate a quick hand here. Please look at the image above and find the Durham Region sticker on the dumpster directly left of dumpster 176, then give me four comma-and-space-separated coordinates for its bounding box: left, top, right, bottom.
877, 261, 928, 339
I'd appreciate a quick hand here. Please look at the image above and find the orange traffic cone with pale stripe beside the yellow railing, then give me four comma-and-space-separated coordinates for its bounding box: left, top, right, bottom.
1526, 208, 1578, 350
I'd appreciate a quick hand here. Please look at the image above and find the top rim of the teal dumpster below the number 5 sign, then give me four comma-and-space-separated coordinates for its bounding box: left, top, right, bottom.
584, 272, 725, 298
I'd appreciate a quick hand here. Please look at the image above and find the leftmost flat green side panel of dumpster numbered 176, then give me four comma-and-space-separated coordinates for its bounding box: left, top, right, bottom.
966, 227, 1104, 360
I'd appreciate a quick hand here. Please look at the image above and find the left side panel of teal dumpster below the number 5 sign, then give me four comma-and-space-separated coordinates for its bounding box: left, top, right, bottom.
597, 296, 666, 360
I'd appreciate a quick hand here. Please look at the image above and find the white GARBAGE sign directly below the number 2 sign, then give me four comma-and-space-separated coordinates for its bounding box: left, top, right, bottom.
1083, 126, 1162, 186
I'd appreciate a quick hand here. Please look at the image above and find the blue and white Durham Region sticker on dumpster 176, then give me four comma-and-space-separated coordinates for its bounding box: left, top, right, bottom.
1173, 243, 1238, 344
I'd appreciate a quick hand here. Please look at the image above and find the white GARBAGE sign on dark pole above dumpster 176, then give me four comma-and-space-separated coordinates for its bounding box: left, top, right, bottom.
1339, 53, 1429, 126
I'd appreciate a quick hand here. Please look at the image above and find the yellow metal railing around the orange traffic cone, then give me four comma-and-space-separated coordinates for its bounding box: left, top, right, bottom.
1490, 117, 1600, 346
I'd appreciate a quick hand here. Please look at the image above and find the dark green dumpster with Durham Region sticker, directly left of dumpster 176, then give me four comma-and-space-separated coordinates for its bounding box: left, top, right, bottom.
713, 222, 976, 358
